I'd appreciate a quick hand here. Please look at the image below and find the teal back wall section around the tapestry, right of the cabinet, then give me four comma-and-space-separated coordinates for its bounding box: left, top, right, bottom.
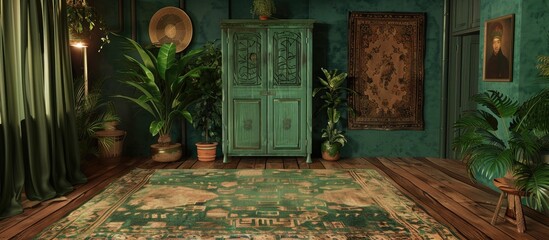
309, 0, 444, 157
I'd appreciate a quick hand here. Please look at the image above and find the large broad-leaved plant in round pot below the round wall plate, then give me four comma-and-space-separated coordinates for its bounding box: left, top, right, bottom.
116, 35, 205, 162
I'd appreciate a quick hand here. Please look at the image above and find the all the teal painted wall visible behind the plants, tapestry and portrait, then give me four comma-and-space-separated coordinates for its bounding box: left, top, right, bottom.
88, 0, 549, 157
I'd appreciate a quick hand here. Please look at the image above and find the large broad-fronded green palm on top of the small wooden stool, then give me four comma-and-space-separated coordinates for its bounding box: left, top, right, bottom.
453, 54, 549, 211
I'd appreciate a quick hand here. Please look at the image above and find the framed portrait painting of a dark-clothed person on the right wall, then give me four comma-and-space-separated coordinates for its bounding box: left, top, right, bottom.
483, 14, 515, 82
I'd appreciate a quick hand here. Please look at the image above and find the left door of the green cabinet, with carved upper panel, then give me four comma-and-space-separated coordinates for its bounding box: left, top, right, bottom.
226, 28, 267, 155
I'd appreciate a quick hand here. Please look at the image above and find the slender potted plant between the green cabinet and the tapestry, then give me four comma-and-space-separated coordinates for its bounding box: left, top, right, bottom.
313, 68, 356, 161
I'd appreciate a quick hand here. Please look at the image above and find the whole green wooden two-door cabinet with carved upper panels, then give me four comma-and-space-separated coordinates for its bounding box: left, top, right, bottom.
221, 19, 314, 162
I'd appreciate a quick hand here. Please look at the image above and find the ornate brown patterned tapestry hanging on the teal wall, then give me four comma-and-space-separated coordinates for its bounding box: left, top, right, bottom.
349, 12, 425, 130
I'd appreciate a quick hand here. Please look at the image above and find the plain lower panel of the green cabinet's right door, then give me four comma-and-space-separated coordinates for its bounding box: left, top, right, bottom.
268, 98, 304, 151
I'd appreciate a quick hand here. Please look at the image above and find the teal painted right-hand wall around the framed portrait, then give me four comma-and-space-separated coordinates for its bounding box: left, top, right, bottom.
478, 0, 549, 188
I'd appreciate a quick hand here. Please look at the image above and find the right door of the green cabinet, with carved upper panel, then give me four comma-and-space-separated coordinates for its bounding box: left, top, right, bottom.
267, 28, 310, 154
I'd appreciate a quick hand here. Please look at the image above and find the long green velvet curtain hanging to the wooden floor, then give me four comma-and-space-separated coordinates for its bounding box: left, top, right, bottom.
0, 0, 86, 218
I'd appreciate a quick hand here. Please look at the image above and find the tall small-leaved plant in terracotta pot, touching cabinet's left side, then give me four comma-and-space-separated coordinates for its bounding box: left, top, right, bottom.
190, 42, 222, 161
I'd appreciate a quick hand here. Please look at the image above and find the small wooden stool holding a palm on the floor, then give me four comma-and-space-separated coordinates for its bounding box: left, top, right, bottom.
491, 178, 526, 233
